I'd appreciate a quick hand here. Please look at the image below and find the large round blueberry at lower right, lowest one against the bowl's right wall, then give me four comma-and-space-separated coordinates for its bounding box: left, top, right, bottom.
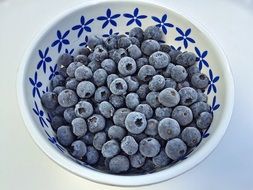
165, 138, 187, 160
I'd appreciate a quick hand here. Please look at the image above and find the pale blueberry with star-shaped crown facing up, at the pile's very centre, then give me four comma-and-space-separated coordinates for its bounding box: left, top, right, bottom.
110, 78, 128, 95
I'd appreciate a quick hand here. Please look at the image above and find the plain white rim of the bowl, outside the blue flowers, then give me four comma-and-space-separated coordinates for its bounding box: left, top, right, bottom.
17, 0, 234, 187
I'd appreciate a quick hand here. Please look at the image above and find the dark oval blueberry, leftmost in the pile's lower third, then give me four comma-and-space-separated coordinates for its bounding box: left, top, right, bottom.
56, 125, 74, 146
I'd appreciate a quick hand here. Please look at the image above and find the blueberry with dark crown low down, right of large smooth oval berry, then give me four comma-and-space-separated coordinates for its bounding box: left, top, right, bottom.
178, 87, 198, 106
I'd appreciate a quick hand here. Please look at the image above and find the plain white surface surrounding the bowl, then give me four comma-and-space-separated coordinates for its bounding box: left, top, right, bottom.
0, 0, 253, 190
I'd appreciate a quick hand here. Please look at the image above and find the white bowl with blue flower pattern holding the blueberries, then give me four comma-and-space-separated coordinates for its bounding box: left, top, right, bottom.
17, 0, 234, 186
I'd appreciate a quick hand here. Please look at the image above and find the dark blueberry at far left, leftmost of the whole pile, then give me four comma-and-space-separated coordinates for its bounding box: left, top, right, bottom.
41, 92, 58, 110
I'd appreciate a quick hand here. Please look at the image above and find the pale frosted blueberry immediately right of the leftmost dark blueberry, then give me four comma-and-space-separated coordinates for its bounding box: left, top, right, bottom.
58, 89, 78, 107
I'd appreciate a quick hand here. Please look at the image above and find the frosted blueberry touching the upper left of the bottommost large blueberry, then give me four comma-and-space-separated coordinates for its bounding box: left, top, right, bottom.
101, 139, 120, 158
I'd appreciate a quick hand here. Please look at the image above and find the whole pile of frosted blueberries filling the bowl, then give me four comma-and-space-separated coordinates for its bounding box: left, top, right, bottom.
41, 26, 213, 173
